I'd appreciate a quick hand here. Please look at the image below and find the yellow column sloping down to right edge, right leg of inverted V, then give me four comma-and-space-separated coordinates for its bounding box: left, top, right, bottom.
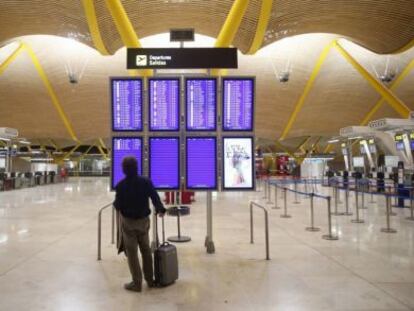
335, 42, 410, 118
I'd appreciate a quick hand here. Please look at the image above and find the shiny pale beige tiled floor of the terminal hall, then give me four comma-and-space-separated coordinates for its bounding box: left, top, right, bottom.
0, 178, 414, 311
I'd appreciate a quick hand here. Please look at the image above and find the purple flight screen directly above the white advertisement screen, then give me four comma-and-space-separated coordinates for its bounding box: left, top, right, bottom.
222, 78, 254, 131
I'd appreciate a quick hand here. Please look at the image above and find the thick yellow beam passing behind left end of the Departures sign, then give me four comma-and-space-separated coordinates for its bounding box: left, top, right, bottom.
105, 0, 153, 76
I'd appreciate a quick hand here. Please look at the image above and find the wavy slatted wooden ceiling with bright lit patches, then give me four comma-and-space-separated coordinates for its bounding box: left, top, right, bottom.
0, 0, 414, 148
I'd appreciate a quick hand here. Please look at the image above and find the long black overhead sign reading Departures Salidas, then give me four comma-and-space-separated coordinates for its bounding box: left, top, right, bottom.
127, 48, 237, 69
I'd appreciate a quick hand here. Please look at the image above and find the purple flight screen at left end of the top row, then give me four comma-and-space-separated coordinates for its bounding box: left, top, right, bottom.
111, 78, 143, 131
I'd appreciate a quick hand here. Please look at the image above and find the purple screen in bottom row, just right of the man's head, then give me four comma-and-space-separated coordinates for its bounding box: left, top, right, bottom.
149, 137, 180, 189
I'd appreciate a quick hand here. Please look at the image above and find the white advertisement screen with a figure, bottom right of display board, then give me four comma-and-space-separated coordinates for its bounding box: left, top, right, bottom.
223, 137, 254, 190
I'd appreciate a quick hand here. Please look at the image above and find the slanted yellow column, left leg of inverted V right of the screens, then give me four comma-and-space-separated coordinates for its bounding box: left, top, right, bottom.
280, 41, 335, 139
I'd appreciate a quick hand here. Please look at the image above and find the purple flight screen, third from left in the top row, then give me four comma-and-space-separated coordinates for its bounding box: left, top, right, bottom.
185, 78, 217, 131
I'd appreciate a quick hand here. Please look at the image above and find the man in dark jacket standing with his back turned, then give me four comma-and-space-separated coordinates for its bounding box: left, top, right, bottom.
114, 157, 166, 292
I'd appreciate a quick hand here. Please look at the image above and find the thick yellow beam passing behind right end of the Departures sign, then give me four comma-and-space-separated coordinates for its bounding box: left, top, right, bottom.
211, 0, 249, 75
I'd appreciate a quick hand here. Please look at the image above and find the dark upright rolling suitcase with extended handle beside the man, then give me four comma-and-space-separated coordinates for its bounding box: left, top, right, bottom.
154, 217, 178, 286
